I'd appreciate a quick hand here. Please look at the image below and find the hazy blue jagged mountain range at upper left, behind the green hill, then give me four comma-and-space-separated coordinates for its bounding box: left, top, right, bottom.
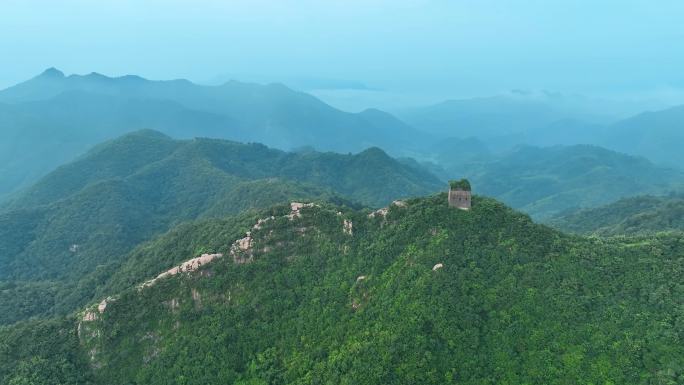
0, 69, 423, 195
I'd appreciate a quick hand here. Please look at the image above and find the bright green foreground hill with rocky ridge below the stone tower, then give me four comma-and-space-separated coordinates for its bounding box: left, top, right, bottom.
0, 194, 684, 385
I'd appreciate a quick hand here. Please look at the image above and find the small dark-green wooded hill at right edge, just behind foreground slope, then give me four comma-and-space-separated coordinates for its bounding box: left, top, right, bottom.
548, 195, 684, 235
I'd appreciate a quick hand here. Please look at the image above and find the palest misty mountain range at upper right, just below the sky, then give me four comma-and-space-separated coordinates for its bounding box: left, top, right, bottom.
398, 95, 684, 168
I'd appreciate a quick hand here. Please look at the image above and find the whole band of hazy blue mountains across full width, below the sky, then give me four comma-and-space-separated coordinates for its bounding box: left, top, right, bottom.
0, 69, 684, 218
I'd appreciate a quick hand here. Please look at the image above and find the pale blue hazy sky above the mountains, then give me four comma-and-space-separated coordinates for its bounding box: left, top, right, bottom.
0, 0, 684, 109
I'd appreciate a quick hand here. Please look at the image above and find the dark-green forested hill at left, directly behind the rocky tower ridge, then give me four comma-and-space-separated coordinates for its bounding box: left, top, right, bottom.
0, 131, 445, 323
